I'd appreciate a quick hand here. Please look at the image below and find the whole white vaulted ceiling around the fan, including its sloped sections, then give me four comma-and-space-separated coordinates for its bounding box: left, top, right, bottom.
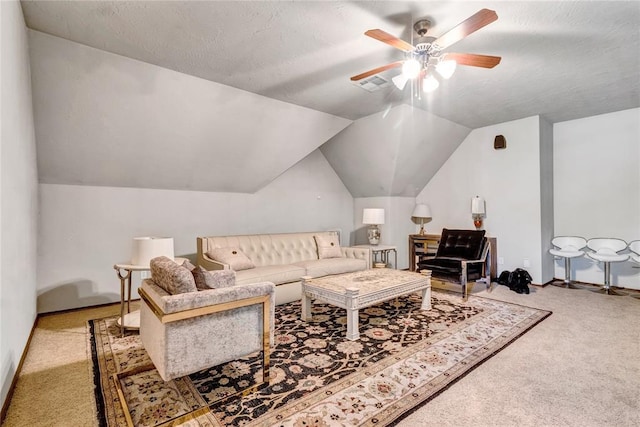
22, 1, 640, 196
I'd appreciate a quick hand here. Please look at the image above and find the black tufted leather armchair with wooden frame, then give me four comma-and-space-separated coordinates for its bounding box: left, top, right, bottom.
418, 228, 491, 300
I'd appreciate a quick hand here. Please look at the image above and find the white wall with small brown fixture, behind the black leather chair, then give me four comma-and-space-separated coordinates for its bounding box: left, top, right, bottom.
416, 116, 547, 283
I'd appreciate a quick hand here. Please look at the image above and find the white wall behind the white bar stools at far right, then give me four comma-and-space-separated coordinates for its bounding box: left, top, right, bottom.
554, 108, 640, 289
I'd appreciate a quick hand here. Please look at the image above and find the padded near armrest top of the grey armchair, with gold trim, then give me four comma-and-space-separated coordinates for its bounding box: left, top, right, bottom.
138, 279, 276, 314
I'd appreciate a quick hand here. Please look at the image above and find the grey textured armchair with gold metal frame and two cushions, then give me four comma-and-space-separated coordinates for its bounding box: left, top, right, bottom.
138, 258, 275, 383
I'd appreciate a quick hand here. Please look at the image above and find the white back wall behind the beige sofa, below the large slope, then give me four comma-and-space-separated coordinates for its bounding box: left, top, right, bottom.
38, 150, 353, 312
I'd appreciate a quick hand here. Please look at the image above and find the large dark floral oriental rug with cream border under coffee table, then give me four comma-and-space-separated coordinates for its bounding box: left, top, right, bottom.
87, 290, 551, 427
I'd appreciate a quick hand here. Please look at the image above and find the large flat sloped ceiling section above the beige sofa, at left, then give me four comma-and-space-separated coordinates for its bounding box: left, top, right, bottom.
29, 31, 351, 193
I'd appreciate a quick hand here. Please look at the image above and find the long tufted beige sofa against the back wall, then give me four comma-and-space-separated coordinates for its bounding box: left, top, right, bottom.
197, 231, 371, 304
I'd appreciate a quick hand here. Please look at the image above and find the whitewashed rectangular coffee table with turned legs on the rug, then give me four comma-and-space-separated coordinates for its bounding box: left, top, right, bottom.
302, 268, 431, 341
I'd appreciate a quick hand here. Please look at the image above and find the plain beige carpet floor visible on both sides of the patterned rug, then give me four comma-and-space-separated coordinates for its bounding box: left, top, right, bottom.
3, 286, 640, 427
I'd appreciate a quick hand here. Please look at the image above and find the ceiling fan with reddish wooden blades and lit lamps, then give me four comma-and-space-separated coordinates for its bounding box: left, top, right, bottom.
351, 9, 502, 94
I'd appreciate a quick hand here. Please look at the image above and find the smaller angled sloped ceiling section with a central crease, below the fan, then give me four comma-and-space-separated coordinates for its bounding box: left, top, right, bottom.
320, 104, 471, 197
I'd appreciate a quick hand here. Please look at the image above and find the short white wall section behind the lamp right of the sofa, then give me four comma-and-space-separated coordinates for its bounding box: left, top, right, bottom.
350, 197, 416, 269
